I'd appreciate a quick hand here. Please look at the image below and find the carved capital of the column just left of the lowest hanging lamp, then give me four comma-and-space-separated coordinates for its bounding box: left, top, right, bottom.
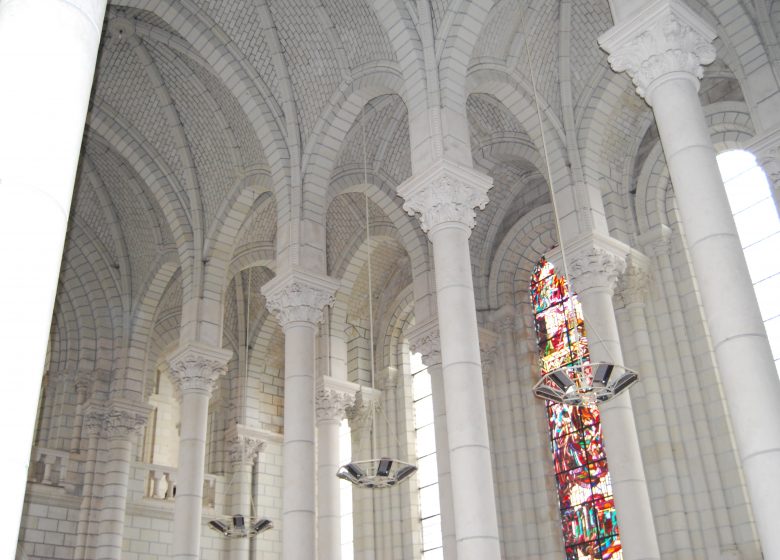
168, 344, 233, 395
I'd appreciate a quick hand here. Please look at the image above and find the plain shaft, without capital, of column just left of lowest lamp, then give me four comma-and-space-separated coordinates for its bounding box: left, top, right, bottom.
173, 389, 210, 560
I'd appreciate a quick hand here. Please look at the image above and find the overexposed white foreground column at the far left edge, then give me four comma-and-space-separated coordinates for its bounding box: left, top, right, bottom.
0, 0, 106, 558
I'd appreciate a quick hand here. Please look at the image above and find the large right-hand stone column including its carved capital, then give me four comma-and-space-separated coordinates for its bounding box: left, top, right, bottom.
599, 0, 780, 558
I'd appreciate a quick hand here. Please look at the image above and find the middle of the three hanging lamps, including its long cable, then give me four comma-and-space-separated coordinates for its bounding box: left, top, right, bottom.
336, 99, 417, 489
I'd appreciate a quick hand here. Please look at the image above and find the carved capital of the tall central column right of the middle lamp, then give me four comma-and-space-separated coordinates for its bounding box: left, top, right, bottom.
398, 160, 493, 233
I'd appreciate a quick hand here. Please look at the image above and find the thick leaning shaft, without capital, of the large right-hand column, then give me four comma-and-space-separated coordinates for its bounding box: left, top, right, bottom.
652, 74, 780, 558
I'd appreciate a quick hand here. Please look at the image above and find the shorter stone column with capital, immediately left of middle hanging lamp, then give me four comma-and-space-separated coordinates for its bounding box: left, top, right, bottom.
316, 379, 355, 560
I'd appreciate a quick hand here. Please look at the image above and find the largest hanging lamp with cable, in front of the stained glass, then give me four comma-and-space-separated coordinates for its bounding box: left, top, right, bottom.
521, 9, 639, 406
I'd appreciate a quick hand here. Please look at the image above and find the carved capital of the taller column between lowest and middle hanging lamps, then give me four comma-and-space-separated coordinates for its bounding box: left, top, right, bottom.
261, 270, 338, 329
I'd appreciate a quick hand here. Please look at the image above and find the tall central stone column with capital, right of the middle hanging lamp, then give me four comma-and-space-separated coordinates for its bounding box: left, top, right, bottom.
398, 160, 500, 560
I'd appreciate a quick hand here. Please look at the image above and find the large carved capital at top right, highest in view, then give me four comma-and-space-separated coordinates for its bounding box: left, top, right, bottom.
599, 0, 716, 100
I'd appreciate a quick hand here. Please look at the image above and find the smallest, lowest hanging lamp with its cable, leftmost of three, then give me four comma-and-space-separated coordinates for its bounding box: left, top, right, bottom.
208, 269, 274, 539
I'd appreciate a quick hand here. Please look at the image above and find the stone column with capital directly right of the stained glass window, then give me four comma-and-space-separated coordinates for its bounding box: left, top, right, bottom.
568, 239, 661, 560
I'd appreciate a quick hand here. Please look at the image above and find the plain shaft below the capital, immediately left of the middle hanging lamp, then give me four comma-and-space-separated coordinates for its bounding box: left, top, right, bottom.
317, 419, 341, 560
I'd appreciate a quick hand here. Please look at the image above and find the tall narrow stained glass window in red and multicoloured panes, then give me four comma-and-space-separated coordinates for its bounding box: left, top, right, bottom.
531, 257, 623, 560
